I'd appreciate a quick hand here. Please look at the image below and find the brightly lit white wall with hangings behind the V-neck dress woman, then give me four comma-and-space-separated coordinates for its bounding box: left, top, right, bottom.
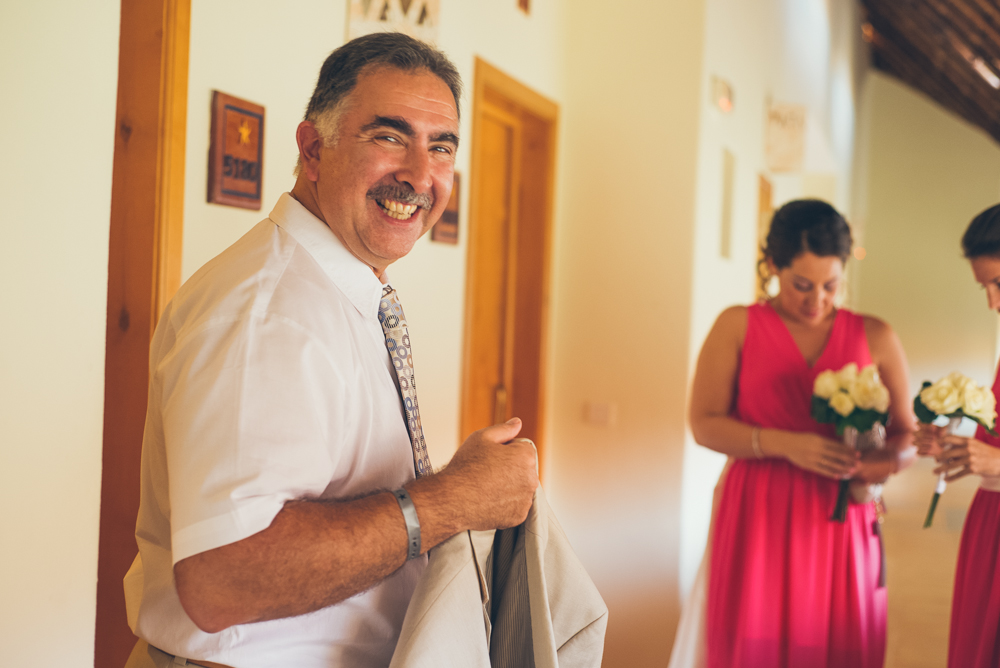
680, 0, 867, 592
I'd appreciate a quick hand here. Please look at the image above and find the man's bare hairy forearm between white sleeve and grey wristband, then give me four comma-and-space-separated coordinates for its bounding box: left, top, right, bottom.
174, 492, 407, 633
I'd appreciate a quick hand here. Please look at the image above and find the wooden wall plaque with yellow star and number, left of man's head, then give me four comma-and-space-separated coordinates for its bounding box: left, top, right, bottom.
208, 91, 264, 211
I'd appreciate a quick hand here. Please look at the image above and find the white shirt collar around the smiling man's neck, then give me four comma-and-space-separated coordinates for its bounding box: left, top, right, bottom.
268, 193, 388, 318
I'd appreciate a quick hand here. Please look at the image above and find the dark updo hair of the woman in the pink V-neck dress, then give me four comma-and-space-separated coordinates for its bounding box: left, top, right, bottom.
759, 199, 852, 290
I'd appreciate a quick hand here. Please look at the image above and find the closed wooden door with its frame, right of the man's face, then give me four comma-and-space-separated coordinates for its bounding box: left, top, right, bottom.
461, 61, 558, 470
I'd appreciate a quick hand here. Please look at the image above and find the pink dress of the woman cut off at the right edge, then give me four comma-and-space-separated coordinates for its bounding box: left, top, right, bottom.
948, 371, 1000, 668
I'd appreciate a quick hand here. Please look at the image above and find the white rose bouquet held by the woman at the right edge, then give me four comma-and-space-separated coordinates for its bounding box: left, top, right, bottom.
913, 371, 997, 529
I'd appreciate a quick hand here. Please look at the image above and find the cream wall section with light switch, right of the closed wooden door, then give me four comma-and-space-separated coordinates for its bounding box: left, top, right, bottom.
546, 0, 705, 668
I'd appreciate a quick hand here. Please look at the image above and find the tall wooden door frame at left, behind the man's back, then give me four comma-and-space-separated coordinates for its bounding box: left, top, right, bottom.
94, 0, 191, 668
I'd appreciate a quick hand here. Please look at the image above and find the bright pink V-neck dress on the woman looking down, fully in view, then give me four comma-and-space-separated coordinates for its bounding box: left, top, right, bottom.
706, 304, 886, 668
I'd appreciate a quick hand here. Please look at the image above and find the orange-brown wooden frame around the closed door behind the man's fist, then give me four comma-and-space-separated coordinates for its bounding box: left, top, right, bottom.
459, 57, 559, 474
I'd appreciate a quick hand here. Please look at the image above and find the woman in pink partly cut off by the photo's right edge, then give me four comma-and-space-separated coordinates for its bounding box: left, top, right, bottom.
916, 205, 1000, 668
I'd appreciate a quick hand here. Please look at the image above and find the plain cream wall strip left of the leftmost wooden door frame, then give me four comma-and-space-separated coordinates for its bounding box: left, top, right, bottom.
0, 0, 119, 668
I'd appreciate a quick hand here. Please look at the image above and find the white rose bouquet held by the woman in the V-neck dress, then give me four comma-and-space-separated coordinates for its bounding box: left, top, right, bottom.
812, 362, 889, 522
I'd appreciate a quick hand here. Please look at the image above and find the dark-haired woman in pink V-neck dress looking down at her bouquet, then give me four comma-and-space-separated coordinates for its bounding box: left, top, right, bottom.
690, 200, 915, 668
